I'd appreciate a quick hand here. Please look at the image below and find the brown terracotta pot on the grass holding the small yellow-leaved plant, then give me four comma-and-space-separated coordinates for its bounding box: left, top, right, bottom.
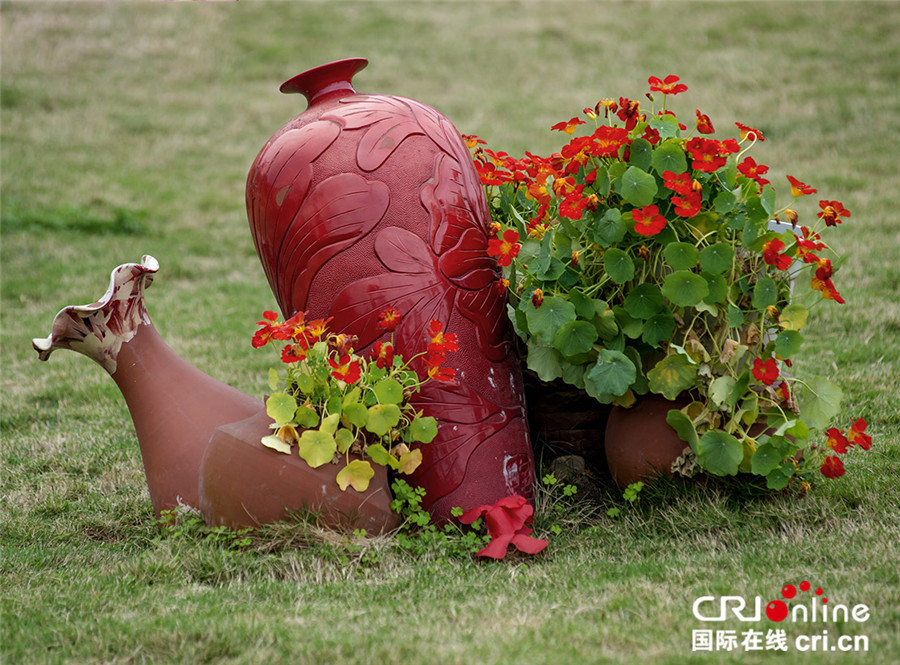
200, 413, 400, 533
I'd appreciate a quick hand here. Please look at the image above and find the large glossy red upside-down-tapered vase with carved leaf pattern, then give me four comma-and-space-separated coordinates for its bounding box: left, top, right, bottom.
247, 59, 534, 520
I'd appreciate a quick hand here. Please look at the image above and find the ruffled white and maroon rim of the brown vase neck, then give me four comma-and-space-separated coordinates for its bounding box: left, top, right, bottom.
31, 255, 159, 374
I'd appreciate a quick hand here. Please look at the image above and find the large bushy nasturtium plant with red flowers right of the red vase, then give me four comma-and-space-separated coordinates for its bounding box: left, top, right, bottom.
465, 75, 872, 489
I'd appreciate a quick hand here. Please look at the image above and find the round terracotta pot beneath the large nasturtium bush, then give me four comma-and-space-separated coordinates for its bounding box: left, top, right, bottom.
605, 394, 688, 488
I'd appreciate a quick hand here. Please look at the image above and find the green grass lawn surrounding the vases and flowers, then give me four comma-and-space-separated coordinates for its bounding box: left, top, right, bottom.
0, 1, 900, 665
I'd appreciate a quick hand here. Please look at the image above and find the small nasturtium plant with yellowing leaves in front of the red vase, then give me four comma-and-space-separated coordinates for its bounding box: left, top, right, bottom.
251, 308, 458, 492
